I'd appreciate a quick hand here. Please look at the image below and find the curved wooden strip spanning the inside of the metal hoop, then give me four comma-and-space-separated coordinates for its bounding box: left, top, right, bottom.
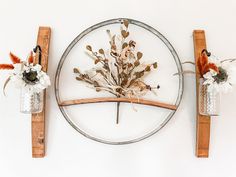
59, 97, 177, 110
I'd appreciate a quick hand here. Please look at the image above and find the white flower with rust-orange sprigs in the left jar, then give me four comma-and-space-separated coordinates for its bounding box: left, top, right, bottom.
0, 46, 51, 94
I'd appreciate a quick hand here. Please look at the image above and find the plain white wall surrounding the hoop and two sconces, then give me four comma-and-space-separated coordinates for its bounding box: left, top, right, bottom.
0, 0, 236, 177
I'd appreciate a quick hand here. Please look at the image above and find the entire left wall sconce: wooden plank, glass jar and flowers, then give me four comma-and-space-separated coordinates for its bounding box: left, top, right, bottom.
0, 27, 51, 158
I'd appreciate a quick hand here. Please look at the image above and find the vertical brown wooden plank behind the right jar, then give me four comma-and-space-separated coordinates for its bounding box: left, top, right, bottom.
193, 30, 211, 157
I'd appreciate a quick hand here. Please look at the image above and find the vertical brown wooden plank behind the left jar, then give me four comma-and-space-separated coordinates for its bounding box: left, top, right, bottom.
32, 27, 51, 158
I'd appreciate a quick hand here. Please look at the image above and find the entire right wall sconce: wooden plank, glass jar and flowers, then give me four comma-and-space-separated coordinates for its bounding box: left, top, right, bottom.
192, 30, 236, 157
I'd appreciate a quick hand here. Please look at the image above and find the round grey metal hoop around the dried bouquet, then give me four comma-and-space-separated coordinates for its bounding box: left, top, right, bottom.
54, 18, 184, 145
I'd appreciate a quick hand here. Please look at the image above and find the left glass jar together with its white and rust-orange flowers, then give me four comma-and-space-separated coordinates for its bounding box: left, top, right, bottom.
0, 46, 50, 114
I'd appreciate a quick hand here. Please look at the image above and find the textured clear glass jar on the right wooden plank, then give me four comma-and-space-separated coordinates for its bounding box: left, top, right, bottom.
198, 78, 220, 116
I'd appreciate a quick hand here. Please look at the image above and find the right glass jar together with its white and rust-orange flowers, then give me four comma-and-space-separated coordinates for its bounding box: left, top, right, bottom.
176, 49, 236, 116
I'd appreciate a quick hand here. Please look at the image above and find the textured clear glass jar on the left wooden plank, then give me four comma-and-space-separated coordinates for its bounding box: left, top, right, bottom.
20, 88, 44, 114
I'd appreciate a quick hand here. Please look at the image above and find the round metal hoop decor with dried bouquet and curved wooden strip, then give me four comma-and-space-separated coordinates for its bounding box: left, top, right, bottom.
55, 18, 183, 145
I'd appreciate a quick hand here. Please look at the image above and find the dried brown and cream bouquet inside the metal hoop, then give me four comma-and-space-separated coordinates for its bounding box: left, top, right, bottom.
74, 20, 160, 124
